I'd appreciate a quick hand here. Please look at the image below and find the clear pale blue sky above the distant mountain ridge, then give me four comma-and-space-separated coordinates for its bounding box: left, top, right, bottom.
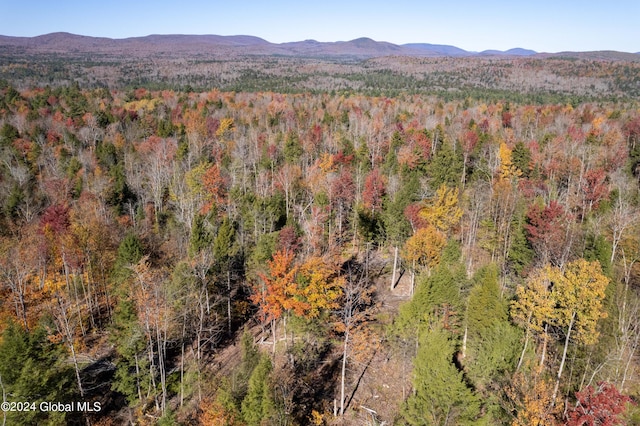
0, 0, 640, 52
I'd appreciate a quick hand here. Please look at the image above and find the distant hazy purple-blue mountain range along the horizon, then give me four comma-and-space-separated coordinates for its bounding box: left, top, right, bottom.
0, 32, 638, 60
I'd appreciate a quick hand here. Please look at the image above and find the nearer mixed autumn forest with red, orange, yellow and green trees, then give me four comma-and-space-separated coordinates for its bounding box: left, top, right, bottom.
0, 70, 640, 426
